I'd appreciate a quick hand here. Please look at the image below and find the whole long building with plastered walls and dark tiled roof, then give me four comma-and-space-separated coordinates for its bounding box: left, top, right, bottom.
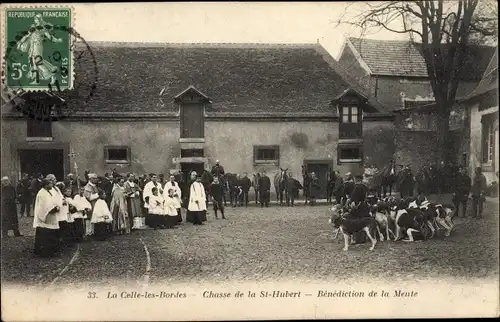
2, 43, 394, 197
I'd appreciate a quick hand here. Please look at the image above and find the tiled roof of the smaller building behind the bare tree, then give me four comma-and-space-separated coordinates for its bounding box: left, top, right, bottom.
348, 38, 495, 81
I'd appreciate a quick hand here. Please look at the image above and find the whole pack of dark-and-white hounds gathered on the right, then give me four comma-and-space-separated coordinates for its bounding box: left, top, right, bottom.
329, 196, 455, 251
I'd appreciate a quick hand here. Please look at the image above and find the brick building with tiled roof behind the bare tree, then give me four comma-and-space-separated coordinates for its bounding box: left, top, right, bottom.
338, 38, 495, 170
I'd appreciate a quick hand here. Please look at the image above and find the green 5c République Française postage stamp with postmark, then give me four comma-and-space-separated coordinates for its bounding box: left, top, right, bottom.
3, 7, 74, 91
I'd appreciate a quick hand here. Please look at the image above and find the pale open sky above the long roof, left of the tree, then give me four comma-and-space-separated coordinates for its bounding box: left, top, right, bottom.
71, 2, 405, 58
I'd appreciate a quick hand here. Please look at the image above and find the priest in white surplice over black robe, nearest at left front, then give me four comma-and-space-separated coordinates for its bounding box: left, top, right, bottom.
33, 177, 62, 257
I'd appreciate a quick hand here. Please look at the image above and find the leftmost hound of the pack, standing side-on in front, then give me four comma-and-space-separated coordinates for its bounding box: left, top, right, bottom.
329, 208, 377, 251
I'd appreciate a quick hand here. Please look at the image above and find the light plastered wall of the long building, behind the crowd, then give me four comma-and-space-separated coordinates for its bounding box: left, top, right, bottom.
2, 120, 394, 189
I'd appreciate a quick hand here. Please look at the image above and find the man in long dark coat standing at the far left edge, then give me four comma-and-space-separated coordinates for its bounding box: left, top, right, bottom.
1, 177, 22, 238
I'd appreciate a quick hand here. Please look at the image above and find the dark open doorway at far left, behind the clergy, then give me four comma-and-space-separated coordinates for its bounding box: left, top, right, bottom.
18, 149, 64, 181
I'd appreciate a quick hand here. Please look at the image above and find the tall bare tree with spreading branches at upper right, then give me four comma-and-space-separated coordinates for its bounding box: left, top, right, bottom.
337, 0, 498, 162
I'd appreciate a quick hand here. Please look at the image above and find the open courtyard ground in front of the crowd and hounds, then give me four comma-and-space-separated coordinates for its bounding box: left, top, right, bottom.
2, 194, 499, 287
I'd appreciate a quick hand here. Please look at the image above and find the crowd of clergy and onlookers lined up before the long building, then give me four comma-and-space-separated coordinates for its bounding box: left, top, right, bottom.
2, 157, 496, 256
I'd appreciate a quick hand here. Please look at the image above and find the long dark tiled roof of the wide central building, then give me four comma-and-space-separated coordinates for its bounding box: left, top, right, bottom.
54, 43, 386, 114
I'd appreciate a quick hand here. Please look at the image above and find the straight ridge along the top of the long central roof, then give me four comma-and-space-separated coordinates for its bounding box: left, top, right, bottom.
78, 41, 317, 49
